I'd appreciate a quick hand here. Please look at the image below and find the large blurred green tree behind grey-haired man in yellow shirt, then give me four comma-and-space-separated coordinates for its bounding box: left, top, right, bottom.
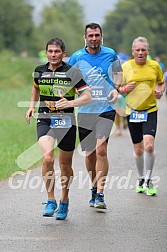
103, 0, 167, 59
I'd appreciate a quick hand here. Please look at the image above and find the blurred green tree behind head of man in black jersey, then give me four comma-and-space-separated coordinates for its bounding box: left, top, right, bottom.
37, 0, 84, 56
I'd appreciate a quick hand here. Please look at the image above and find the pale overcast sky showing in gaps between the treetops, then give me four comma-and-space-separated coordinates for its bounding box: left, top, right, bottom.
28, 0, 118, 24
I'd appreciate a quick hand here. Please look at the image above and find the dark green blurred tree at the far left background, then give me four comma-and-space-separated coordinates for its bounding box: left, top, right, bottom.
0, 0, 34, 53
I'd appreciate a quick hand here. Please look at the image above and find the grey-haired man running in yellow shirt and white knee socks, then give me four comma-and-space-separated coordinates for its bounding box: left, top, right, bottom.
119, 37, 165, 195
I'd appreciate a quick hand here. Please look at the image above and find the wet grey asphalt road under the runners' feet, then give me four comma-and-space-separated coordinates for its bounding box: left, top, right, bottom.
0, 97, 167, 252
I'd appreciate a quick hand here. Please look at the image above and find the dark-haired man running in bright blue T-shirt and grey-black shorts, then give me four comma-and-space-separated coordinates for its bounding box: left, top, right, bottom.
68, 23, 122, 209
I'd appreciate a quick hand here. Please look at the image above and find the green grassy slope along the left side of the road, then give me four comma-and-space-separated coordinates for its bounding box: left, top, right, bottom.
0, 52, 40, 180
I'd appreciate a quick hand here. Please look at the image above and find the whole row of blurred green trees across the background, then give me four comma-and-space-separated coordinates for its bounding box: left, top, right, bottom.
0, 0, 167, 65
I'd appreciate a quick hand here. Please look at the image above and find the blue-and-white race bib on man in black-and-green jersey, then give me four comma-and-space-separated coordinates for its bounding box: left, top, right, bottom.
50, 115, 72, 128
